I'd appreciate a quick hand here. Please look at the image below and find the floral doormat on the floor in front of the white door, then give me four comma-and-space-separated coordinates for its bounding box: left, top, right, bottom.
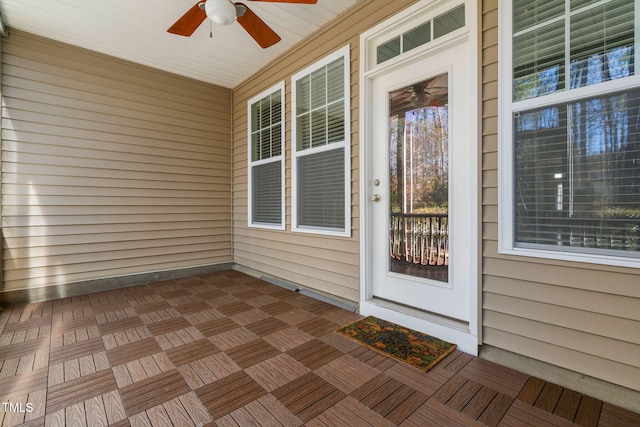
337, 316, 456, 372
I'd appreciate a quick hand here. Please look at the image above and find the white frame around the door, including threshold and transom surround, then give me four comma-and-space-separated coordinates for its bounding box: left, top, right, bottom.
359, 0, 482, 355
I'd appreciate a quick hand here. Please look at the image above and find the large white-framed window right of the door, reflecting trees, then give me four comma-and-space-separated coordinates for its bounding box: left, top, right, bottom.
500, 0, 640, 265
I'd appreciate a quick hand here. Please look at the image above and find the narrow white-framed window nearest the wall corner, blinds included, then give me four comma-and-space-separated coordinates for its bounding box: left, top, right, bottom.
248, 82, 285, 230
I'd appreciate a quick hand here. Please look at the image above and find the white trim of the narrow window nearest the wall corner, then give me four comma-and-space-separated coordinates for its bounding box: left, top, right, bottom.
247, 80, 286, 230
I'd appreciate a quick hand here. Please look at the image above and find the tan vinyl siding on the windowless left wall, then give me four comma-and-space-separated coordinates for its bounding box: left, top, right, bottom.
2, 30, 231, 290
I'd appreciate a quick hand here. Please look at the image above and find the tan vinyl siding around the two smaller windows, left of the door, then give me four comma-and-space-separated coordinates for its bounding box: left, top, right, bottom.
233, 0, 415, 301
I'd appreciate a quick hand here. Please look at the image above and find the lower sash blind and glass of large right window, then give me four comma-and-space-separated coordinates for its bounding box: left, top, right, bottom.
514, 89, 640, 252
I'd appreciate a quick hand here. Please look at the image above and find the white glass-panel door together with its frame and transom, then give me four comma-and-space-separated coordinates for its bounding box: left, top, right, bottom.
360, 0, 480, 354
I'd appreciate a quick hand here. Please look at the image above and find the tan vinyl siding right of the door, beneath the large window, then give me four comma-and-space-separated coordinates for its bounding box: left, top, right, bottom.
482, 0, 640, 390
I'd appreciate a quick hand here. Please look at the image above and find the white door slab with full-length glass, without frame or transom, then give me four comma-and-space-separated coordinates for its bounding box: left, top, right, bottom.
370, 42, 476, 322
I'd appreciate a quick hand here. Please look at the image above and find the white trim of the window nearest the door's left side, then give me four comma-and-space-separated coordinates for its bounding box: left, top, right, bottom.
291, 45, 351, 237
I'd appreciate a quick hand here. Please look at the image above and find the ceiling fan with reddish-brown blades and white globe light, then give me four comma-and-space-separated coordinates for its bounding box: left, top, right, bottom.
167, 0, 317, 48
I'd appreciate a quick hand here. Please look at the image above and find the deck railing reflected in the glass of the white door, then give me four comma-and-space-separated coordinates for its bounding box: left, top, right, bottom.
389, 213, 449, 266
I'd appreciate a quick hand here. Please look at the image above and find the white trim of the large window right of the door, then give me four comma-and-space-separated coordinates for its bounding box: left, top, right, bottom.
498, 0, 640, 268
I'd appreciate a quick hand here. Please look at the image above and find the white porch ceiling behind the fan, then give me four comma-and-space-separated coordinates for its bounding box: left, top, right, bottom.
0, 0, 360, 88
